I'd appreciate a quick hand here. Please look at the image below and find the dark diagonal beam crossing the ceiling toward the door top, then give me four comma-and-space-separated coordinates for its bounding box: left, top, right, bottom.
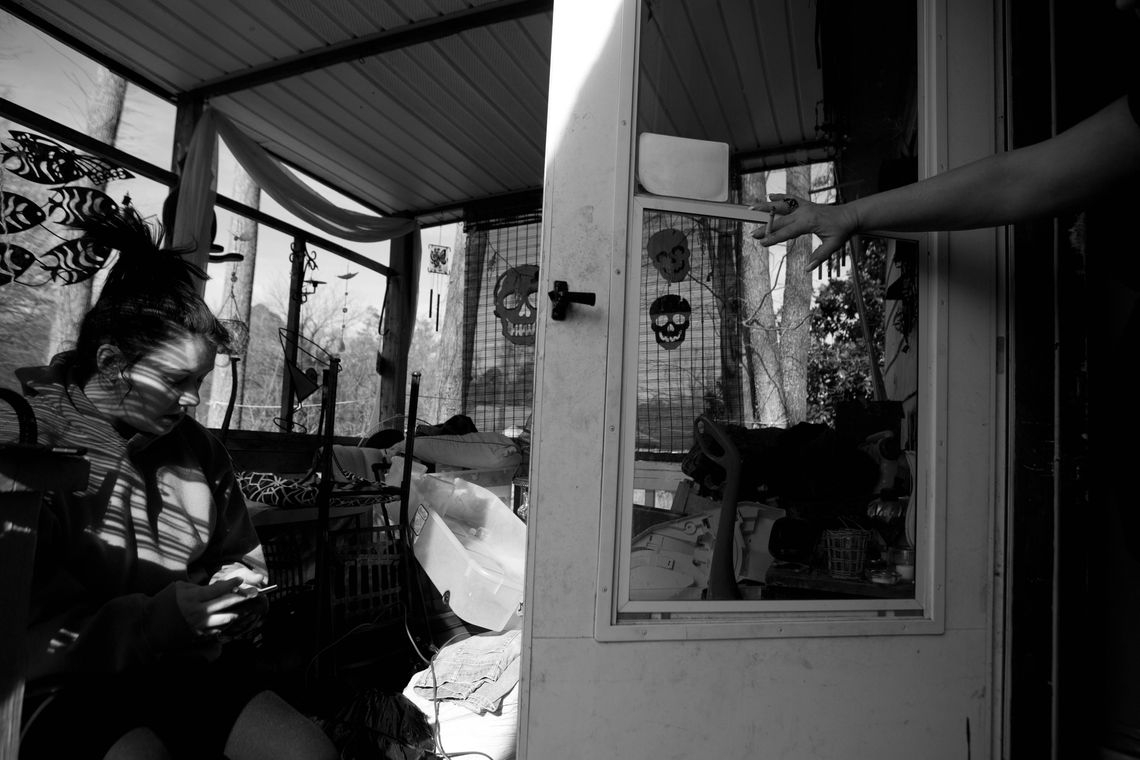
189, 0, 554, 98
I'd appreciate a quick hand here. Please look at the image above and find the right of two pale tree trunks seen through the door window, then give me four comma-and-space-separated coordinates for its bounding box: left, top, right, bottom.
780, 166, 812, 425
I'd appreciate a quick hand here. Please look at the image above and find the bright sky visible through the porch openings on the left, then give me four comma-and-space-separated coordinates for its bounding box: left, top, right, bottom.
0, 10, 456, 330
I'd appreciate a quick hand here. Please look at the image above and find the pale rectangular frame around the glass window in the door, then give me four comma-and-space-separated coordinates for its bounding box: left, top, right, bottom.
594, 0, 948, 641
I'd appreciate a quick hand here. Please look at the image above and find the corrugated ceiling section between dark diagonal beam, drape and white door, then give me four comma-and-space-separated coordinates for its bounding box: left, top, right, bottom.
192, 11, 551, 219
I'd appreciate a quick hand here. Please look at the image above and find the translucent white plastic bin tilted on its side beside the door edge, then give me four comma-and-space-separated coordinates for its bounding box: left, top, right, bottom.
409, 473, 527, 631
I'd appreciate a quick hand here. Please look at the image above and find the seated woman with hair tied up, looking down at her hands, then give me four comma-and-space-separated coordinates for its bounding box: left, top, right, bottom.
17, 206, 335, 760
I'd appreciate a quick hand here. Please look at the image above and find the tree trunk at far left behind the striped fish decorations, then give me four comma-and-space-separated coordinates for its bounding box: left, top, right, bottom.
46, 66, 127, 359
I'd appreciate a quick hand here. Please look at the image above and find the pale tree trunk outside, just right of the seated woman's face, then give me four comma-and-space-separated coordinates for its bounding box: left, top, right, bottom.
207, 165, 261, 430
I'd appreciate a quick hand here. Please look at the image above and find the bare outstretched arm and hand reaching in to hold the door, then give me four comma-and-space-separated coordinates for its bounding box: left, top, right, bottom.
754, 98, 1140, 268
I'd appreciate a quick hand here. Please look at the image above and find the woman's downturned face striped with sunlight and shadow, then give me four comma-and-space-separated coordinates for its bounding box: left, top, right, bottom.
111, 335, 215, 435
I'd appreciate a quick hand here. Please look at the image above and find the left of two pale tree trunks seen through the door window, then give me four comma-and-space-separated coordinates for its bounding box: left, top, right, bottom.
740, 172, 788, 426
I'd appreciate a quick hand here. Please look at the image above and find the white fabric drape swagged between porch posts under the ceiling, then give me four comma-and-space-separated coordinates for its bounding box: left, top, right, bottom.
172, 108, 420, 273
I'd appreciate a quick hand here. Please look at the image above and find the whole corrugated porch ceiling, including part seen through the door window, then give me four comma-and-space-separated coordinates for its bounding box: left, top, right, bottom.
0, 0, 839, 226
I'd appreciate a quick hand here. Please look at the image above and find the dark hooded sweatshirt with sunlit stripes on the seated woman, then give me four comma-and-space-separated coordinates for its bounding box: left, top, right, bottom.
17, 354, 264, 678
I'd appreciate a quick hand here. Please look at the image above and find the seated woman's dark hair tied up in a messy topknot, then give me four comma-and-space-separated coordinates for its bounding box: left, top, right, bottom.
74, 203, 229, 383
